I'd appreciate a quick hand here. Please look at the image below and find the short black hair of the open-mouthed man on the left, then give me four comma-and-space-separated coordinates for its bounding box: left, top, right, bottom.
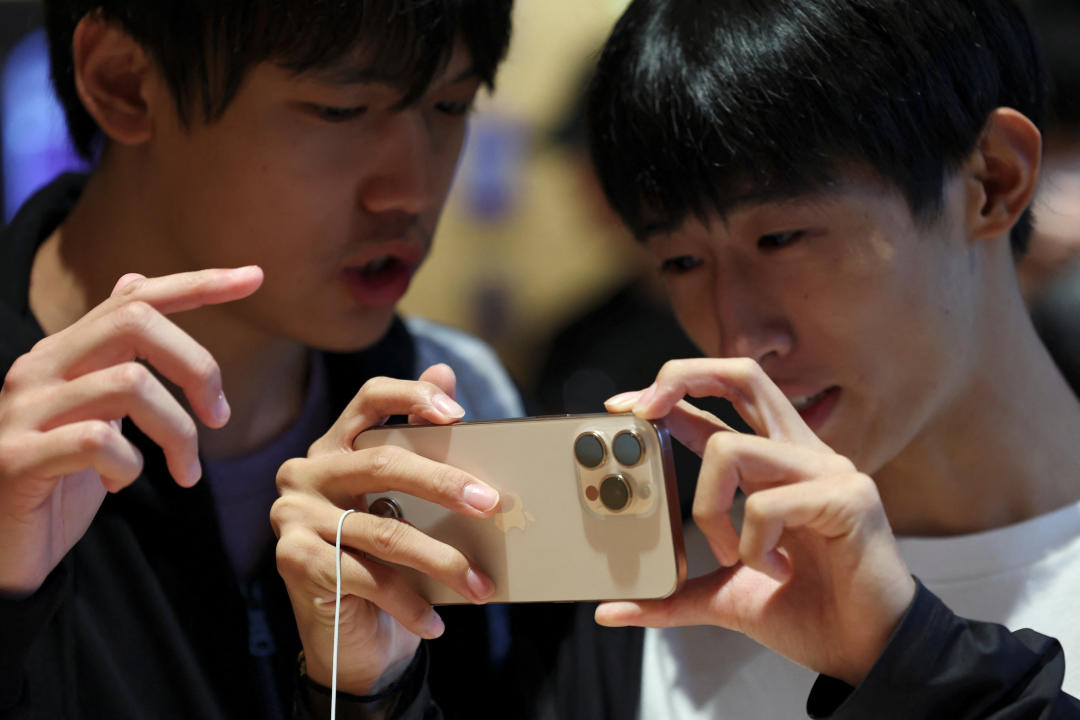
44, 0, 513, 158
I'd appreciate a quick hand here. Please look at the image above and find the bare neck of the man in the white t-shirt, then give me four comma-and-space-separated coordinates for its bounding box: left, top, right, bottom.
874, 252, 1080, 535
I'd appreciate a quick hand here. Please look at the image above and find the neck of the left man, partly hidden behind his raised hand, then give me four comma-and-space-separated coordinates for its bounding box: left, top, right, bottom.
29, 160, 308, 459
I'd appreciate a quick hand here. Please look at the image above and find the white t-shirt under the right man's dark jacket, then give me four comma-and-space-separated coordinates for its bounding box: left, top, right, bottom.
638, 503, 1080, 720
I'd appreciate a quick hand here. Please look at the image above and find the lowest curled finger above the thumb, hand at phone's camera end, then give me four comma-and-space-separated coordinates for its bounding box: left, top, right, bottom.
739, 473, 888, 582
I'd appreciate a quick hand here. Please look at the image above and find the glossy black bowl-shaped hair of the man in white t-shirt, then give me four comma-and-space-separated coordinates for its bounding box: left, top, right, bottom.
588, 0, 1045, 254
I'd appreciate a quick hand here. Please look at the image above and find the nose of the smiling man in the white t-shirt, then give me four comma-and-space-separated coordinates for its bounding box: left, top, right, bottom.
713, 264, 795, 367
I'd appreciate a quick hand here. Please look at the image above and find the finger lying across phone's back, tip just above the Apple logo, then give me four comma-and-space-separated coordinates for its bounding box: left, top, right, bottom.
278, 446, 499, 517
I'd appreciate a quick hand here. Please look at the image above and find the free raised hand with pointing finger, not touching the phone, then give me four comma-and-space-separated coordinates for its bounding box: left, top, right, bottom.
0, 267, 262, 597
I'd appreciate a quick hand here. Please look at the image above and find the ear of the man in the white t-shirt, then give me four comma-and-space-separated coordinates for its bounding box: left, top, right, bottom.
968, 108, 1042, 240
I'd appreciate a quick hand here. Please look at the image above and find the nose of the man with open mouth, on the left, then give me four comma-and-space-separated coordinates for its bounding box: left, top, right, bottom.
360, 108, 435, 214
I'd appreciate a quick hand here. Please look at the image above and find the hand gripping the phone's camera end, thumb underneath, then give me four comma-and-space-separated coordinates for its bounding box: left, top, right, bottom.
596, 358, 915, 684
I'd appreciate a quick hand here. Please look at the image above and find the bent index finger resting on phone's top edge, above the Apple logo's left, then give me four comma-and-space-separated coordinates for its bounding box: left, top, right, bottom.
311, 378, 465, 454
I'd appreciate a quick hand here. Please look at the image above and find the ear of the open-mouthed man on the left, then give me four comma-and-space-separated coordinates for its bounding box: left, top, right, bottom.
71, 12, 153, 145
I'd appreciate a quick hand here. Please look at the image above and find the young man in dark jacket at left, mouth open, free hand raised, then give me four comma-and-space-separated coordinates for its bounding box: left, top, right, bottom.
0, 0, 519, 718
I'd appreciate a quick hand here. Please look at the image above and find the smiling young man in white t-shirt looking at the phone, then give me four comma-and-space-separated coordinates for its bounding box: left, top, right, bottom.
321, 0, 1080, 720
